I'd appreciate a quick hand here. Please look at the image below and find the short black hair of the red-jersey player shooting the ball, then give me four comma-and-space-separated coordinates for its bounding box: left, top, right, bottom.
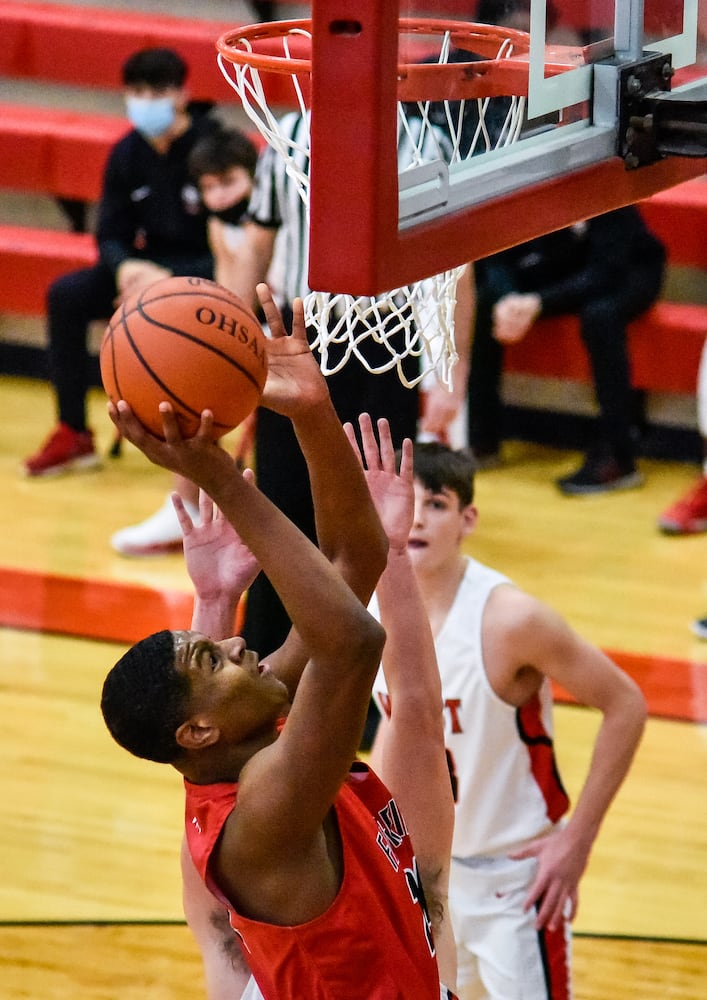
101, 630, 189, 764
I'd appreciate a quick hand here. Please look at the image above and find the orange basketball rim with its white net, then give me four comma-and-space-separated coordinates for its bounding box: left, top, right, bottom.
217, 18, 530, 389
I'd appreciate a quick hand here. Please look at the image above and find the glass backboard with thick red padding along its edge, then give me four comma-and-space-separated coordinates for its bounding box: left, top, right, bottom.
302, 0, 707, 294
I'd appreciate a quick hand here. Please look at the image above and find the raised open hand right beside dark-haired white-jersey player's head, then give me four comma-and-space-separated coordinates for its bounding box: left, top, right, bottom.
344, 413, 414, 550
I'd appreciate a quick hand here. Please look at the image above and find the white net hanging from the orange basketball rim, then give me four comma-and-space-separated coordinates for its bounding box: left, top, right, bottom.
218, 21, 525, 389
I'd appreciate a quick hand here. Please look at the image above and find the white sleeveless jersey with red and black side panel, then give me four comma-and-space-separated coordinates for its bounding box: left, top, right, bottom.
371, 559, 568, 858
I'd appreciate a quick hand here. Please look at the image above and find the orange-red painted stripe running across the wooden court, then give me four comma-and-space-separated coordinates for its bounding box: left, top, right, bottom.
0, 567, 707, 723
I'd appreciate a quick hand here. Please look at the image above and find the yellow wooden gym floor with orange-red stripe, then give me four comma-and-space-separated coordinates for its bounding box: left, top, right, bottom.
0, 377, 707, 1000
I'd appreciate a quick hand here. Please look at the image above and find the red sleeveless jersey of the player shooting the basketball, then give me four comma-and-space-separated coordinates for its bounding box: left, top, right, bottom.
184, 763, 440, 1000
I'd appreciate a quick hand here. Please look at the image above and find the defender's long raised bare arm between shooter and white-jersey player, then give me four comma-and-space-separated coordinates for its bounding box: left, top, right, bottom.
345, 414, 456, 988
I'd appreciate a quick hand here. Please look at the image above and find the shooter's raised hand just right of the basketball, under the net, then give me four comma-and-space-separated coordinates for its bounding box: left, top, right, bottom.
257, 284, 329, 420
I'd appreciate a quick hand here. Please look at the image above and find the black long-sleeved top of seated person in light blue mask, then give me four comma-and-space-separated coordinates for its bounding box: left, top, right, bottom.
96, 105, 217, 275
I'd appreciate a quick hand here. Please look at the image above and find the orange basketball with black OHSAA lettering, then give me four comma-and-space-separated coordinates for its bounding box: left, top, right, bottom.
100, 277, 268, 438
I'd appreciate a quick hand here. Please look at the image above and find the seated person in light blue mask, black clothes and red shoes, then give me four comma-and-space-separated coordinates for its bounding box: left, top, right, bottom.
24, 49, 218, 477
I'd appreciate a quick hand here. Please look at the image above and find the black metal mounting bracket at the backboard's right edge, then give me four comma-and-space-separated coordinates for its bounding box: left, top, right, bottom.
604, 52, 707, 170
